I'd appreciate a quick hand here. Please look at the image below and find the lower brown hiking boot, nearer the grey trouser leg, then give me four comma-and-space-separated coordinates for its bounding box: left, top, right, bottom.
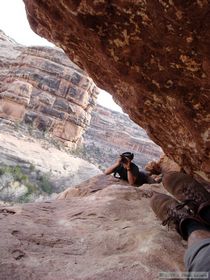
150, 192, 204, 240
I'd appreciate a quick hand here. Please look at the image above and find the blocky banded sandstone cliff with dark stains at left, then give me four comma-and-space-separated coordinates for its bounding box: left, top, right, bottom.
0, 32, 98, 148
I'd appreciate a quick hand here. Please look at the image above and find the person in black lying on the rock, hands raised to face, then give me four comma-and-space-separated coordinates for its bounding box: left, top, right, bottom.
104, 152, 149, 186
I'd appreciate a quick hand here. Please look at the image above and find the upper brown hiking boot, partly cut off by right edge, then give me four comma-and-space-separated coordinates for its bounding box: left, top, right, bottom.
162, 172, 210, 226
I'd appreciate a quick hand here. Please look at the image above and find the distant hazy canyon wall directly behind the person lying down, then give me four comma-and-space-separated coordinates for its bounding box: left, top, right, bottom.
84, 105, 162, 168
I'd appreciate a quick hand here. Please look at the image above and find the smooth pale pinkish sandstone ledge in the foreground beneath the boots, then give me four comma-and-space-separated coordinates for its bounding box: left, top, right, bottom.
0, 175, 186, 280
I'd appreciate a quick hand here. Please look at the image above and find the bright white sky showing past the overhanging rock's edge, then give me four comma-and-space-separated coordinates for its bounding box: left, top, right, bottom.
0, 0, 122, 112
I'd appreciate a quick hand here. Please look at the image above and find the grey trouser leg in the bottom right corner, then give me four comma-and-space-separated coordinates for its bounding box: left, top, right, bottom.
184, 238, 210, 280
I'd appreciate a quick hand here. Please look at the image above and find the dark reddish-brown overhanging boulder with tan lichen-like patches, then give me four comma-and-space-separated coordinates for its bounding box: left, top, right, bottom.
24, 0, 210, 180
